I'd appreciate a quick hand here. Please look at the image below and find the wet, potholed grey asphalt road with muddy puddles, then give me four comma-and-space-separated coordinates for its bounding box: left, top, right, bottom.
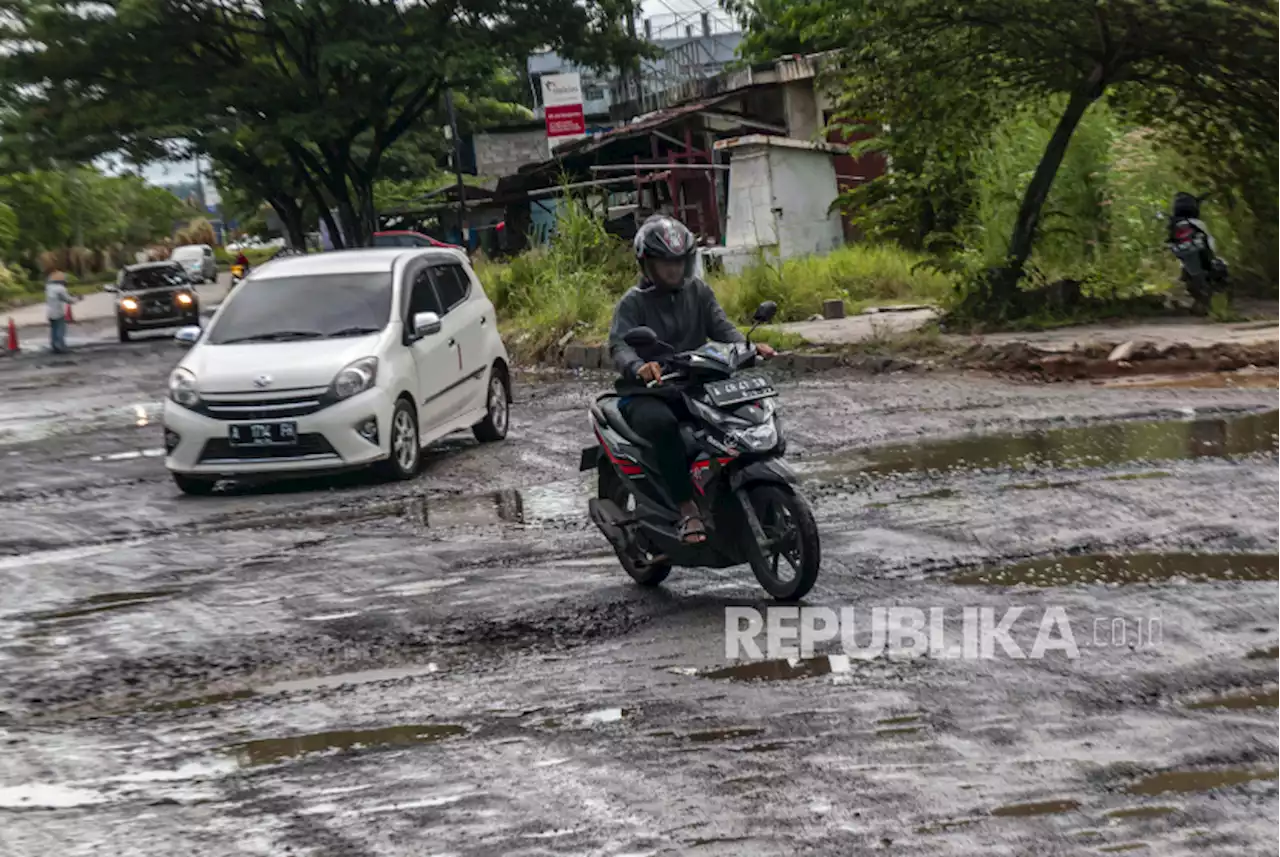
0, 342, 1280, 857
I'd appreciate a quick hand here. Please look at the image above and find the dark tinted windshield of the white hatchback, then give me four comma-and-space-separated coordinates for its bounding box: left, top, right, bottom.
207, 272, 393, 345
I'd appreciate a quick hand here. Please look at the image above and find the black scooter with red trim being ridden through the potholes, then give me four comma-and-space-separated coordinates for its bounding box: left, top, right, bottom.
580, 301, 822, 601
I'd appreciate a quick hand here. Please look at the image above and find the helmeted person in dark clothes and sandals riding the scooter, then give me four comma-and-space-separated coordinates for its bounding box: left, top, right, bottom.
609, 215, 774, 544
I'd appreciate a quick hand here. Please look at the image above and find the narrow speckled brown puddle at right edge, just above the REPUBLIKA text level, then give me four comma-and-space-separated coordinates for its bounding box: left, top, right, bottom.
950, 554, 1280, 587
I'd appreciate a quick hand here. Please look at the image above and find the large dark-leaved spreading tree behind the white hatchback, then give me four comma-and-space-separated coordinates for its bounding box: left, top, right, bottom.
0, 0, 635, 244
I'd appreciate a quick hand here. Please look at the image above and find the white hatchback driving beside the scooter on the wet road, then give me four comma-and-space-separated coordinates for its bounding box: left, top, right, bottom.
164, 248, 511, 494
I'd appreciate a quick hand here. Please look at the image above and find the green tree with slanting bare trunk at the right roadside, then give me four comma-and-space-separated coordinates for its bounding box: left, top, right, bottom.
737, 0, 1280, 312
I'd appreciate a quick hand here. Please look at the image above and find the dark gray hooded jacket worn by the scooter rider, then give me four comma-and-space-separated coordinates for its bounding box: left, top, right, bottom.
609, 278, 746, 382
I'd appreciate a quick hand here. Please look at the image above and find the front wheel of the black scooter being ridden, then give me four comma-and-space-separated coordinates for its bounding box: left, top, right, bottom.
739, 485, 822, 601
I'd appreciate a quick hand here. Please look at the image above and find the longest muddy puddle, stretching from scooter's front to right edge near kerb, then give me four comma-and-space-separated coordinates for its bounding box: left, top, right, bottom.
797, 411, 1280, 477
